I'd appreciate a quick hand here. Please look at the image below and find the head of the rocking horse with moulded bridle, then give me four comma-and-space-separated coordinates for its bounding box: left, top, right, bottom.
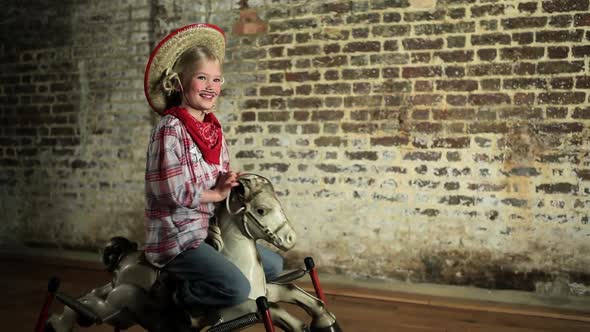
226, 173, 296, 250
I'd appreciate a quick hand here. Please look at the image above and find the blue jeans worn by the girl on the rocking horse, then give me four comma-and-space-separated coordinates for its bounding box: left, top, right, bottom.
165, 242, 283, 309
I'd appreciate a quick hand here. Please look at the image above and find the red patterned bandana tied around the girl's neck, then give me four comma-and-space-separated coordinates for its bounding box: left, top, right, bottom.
162, 106, 223, 165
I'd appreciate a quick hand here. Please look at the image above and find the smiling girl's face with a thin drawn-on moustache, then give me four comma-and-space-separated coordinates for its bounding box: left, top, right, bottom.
181, 60, 223, 112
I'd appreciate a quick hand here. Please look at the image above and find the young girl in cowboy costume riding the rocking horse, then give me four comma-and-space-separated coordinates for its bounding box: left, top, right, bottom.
144, 24, 282, 309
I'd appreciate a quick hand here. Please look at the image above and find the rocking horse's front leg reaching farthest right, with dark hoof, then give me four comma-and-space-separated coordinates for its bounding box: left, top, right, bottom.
266, 283, 340, 331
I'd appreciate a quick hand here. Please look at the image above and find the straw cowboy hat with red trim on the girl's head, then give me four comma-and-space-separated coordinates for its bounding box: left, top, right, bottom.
143, 23, 225, 113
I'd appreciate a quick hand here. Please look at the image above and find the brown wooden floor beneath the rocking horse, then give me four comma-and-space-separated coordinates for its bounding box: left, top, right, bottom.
0, 255, 590, 332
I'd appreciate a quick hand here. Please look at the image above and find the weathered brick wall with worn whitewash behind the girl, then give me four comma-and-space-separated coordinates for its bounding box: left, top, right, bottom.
0, 0, 590, 294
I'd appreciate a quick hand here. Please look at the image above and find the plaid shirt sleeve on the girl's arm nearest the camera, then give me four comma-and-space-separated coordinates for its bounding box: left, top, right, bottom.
146, 125, 201, 208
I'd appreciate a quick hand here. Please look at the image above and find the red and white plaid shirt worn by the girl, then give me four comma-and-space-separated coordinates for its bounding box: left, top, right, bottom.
144, 115, 229, 267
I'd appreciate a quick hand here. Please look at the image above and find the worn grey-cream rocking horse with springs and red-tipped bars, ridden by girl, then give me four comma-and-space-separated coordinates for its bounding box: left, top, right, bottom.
36, 174, 341, 332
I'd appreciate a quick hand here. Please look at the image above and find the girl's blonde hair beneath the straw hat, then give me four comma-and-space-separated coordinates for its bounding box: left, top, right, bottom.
162, 45, 221, 108
